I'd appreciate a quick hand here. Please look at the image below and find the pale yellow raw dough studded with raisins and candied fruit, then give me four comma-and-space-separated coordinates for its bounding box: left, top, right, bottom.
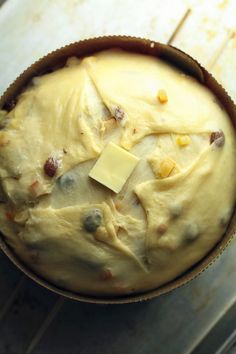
0, 49, 236, 295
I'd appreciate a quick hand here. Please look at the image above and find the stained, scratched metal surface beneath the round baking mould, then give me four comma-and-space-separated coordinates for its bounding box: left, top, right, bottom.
0, 0, 236, 354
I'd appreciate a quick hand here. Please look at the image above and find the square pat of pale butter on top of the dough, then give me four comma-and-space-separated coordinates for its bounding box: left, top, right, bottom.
89, 143, 139, 193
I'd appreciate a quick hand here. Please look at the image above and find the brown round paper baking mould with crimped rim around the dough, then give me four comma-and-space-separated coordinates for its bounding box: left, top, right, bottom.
0, 36, 236, 304
